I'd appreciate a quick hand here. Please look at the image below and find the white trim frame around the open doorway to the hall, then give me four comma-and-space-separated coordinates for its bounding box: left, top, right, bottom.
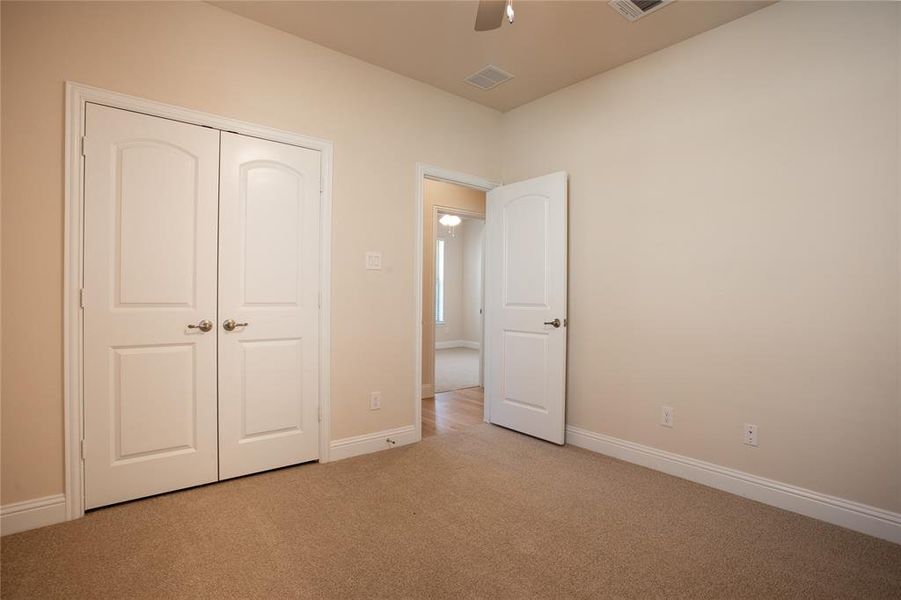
413, 163, 501, 442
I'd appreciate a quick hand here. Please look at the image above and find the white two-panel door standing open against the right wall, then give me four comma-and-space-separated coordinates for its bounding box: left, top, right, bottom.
485, 172, 567, 444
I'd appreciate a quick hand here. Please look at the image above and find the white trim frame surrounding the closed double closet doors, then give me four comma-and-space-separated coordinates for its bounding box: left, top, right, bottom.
63, 81, 333, 520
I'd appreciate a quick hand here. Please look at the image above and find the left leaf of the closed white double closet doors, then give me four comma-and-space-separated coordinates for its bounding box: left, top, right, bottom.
84, 104, 219, 508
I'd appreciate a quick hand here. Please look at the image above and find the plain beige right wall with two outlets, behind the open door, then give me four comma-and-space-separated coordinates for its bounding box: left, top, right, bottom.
504, 2, 901, 511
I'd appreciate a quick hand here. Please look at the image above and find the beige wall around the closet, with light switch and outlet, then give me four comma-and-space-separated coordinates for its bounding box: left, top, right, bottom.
0, 2, 500, 504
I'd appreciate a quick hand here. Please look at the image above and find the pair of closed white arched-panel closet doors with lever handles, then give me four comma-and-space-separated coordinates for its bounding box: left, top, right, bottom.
82, 104, 320, 508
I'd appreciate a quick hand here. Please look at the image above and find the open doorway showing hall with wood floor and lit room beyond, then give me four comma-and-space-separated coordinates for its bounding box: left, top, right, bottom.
416, 167, 496, 438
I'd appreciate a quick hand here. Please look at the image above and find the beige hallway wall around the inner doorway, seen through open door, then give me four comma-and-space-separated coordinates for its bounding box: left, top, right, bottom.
422, 179, 486, 396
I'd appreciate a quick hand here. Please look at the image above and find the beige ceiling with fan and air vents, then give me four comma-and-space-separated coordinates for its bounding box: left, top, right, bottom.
213, 0, 772, 111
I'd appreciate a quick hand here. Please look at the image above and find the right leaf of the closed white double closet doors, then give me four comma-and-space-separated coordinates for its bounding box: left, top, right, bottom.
218, 132, 320, 479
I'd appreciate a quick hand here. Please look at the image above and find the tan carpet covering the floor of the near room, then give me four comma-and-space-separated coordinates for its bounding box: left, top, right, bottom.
2, 425, 901, 600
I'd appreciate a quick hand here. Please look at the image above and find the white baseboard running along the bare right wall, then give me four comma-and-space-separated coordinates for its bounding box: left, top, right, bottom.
566, 426, 901, 544
